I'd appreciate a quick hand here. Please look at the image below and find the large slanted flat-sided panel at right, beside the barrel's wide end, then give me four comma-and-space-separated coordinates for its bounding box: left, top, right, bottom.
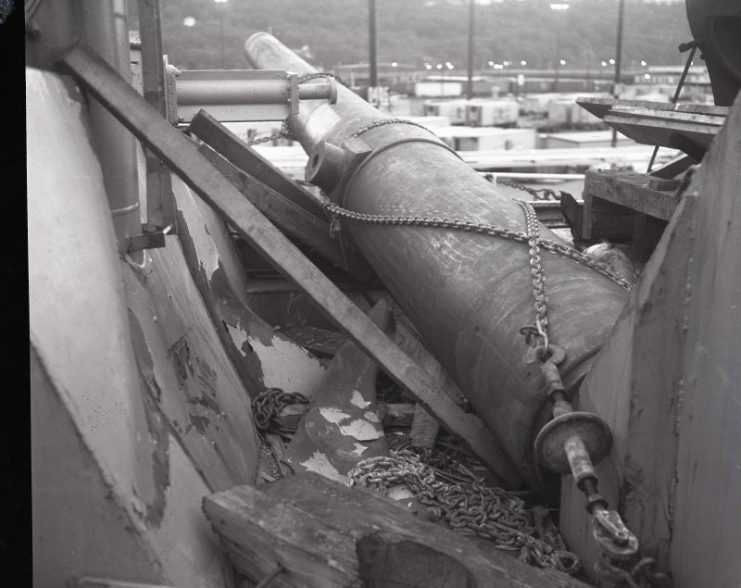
561, 89, 741, 588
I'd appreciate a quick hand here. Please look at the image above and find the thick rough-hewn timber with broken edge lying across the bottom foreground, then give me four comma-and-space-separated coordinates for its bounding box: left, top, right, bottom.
203, 474, 583, 588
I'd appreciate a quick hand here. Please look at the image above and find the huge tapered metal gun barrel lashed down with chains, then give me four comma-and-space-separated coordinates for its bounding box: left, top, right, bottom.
245, 33, 627, 488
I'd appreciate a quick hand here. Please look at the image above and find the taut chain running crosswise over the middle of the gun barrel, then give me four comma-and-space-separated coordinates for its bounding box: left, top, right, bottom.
325, 202, 632, 291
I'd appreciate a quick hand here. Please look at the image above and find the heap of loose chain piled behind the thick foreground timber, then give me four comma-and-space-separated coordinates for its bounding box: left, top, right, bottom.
348, 449, 581, 574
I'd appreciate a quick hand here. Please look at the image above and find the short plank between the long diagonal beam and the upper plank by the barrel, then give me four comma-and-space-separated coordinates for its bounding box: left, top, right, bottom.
199, 145, 373, 282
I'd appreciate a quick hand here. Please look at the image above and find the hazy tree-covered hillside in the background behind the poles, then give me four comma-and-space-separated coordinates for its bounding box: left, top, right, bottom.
156, 0, 691, 69
